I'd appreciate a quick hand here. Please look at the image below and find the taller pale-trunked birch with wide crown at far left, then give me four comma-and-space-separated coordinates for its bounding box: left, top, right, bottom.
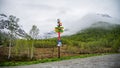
0, 14, 19, 59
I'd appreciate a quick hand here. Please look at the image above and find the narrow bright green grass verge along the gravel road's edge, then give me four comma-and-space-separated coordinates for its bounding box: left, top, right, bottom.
0, 53, 117, 66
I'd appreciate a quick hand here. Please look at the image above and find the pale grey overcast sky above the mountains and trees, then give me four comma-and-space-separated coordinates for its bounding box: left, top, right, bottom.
0, 0, 120, 33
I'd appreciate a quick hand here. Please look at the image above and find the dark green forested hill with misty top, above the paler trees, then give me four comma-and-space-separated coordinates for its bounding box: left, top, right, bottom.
64, 22, 120, 42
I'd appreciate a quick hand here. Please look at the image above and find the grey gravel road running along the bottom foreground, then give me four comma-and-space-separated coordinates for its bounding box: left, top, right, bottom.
0, 54, 120, 68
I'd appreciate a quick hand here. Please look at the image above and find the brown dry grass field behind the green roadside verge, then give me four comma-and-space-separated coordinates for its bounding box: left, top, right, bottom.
0, 46, 111, 61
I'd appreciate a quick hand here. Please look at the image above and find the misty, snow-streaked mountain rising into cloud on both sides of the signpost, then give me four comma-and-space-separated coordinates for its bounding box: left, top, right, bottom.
40, 13, 120, 39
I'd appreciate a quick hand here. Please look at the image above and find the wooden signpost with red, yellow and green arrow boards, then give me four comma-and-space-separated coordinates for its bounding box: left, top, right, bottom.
55, 19, 64, 58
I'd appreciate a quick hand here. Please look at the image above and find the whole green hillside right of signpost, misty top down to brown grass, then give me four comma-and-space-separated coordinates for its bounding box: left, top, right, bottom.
59, 22, 120, 52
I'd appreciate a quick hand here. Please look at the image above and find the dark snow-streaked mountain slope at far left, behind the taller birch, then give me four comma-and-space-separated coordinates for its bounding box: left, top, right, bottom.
0, 14, 27, 41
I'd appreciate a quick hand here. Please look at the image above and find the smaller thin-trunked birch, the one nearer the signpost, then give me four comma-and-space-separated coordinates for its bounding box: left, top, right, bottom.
29, 25, 39, 59
